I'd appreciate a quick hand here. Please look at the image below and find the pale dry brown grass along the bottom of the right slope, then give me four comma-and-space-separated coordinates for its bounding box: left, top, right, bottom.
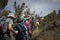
32, 27, 60, 40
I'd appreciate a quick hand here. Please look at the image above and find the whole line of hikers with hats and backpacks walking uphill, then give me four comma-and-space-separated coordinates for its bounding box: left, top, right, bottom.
0, 13, 40, 40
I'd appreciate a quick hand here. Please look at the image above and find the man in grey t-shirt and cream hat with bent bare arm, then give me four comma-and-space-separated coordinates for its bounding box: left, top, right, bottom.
6, 13, 18, 40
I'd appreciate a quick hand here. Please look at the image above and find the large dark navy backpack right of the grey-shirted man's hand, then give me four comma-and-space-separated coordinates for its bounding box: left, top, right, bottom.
13, 23, 26, 40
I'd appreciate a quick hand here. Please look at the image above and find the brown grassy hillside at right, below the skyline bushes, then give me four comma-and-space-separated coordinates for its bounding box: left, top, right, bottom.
32, 15, 60, 40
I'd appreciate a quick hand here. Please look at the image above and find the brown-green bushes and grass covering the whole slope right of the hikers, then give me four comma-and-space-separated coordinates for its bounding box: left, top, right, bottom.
33, 11, 60, 40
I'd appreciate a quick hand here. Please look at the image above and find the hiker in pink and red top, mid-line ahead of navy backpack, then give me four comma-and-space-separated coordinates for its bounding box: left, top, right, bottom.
24, 17, 32, 40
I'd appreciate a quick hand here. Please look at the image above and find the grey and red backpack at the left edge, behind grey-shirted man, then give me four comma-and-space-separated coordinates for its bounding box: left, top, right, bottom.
0, 18, 8, 35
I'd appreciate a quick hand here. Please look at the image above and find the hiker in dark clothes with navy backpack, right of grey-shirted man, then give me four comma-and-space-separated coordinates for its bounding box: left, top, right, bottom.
14, 15, 27, 40
